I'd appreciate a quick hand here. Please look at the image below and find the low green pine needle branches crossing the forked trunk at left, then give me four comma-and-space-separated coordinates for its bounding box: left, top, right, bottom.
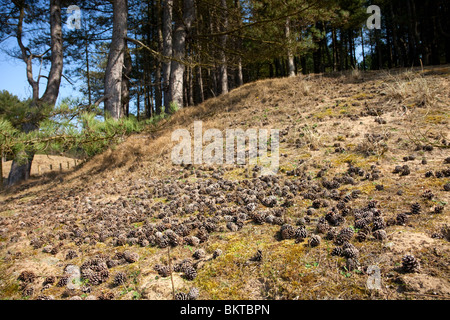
0, 92, 150, 161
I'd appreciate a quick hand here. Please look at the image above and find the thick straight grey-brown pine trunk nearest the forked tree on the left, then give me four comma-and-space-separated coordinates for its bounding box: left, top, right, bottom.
105, 0, 128, 119
